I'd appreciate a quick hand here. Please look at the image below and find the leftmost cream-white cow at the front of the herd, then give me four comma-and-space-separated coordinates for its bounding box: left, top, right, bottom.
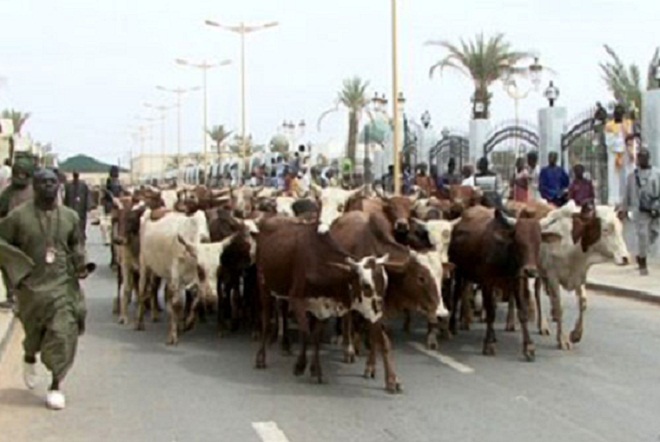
137, 210, 211, 344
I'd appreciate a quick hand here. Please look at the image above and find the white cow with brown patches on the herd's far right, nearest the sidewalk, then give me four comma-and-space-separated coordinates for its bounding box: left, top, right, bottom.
536, 202, 629, 350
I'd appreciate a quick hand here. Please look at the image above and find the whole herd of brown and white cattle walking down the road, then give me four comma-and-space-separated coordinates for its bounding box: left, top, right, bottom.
96, 186, 628, 392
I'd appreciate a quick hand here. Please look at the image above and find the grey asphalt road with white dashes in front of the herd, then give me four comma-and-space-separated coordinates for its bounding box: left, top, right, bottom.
0, 231, 660, 442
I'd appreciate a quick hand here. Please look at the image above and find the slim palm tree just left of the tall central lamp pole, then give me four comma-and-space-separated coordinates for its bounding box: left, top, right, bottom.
318, 77, 369, 165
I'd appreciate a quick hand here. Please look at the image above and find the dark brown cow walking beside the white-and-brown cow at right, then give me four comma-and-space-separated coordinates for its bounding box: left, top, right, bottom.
449, 206, 541, 361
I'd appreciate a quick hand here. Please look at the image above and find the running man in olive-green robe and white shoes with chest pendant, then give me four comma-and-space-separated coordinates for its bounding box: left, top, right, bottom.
0, 169, 95, 410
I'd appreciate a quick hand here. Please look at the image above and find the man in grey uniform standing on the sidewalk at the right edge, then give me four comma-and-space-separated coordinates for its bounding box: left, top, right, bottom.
619, 149, 660, 276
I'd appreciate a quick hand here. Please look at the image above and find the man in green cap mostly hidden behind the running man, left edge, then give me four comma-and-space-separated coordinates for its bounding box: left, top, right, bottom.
0, 158, 34, 309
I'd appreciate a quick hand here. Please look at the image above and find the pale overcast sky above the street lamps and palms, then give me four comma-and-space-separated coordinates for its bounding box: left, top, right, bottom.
0, 0, 660, 164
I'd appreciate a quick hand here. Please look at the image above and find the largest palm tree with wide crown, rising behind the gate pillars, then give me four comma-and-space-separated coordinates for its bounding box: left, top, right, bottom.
426, 34, 532, 119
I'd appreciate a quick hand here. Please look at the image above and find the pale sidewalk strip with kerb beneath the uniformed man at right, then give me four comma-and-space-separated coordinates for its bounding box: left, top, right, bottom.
587, 263, 660, 304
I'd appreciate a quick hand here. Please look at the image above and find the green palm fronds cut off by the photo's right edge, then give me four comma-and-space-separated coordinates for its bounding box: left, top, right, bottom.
599, 45, 660, 110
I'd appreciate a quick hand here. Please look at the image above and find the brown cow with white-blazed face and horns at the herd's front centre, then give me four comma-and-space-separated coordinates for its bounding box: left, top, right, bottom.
256, 217, 397, 392
